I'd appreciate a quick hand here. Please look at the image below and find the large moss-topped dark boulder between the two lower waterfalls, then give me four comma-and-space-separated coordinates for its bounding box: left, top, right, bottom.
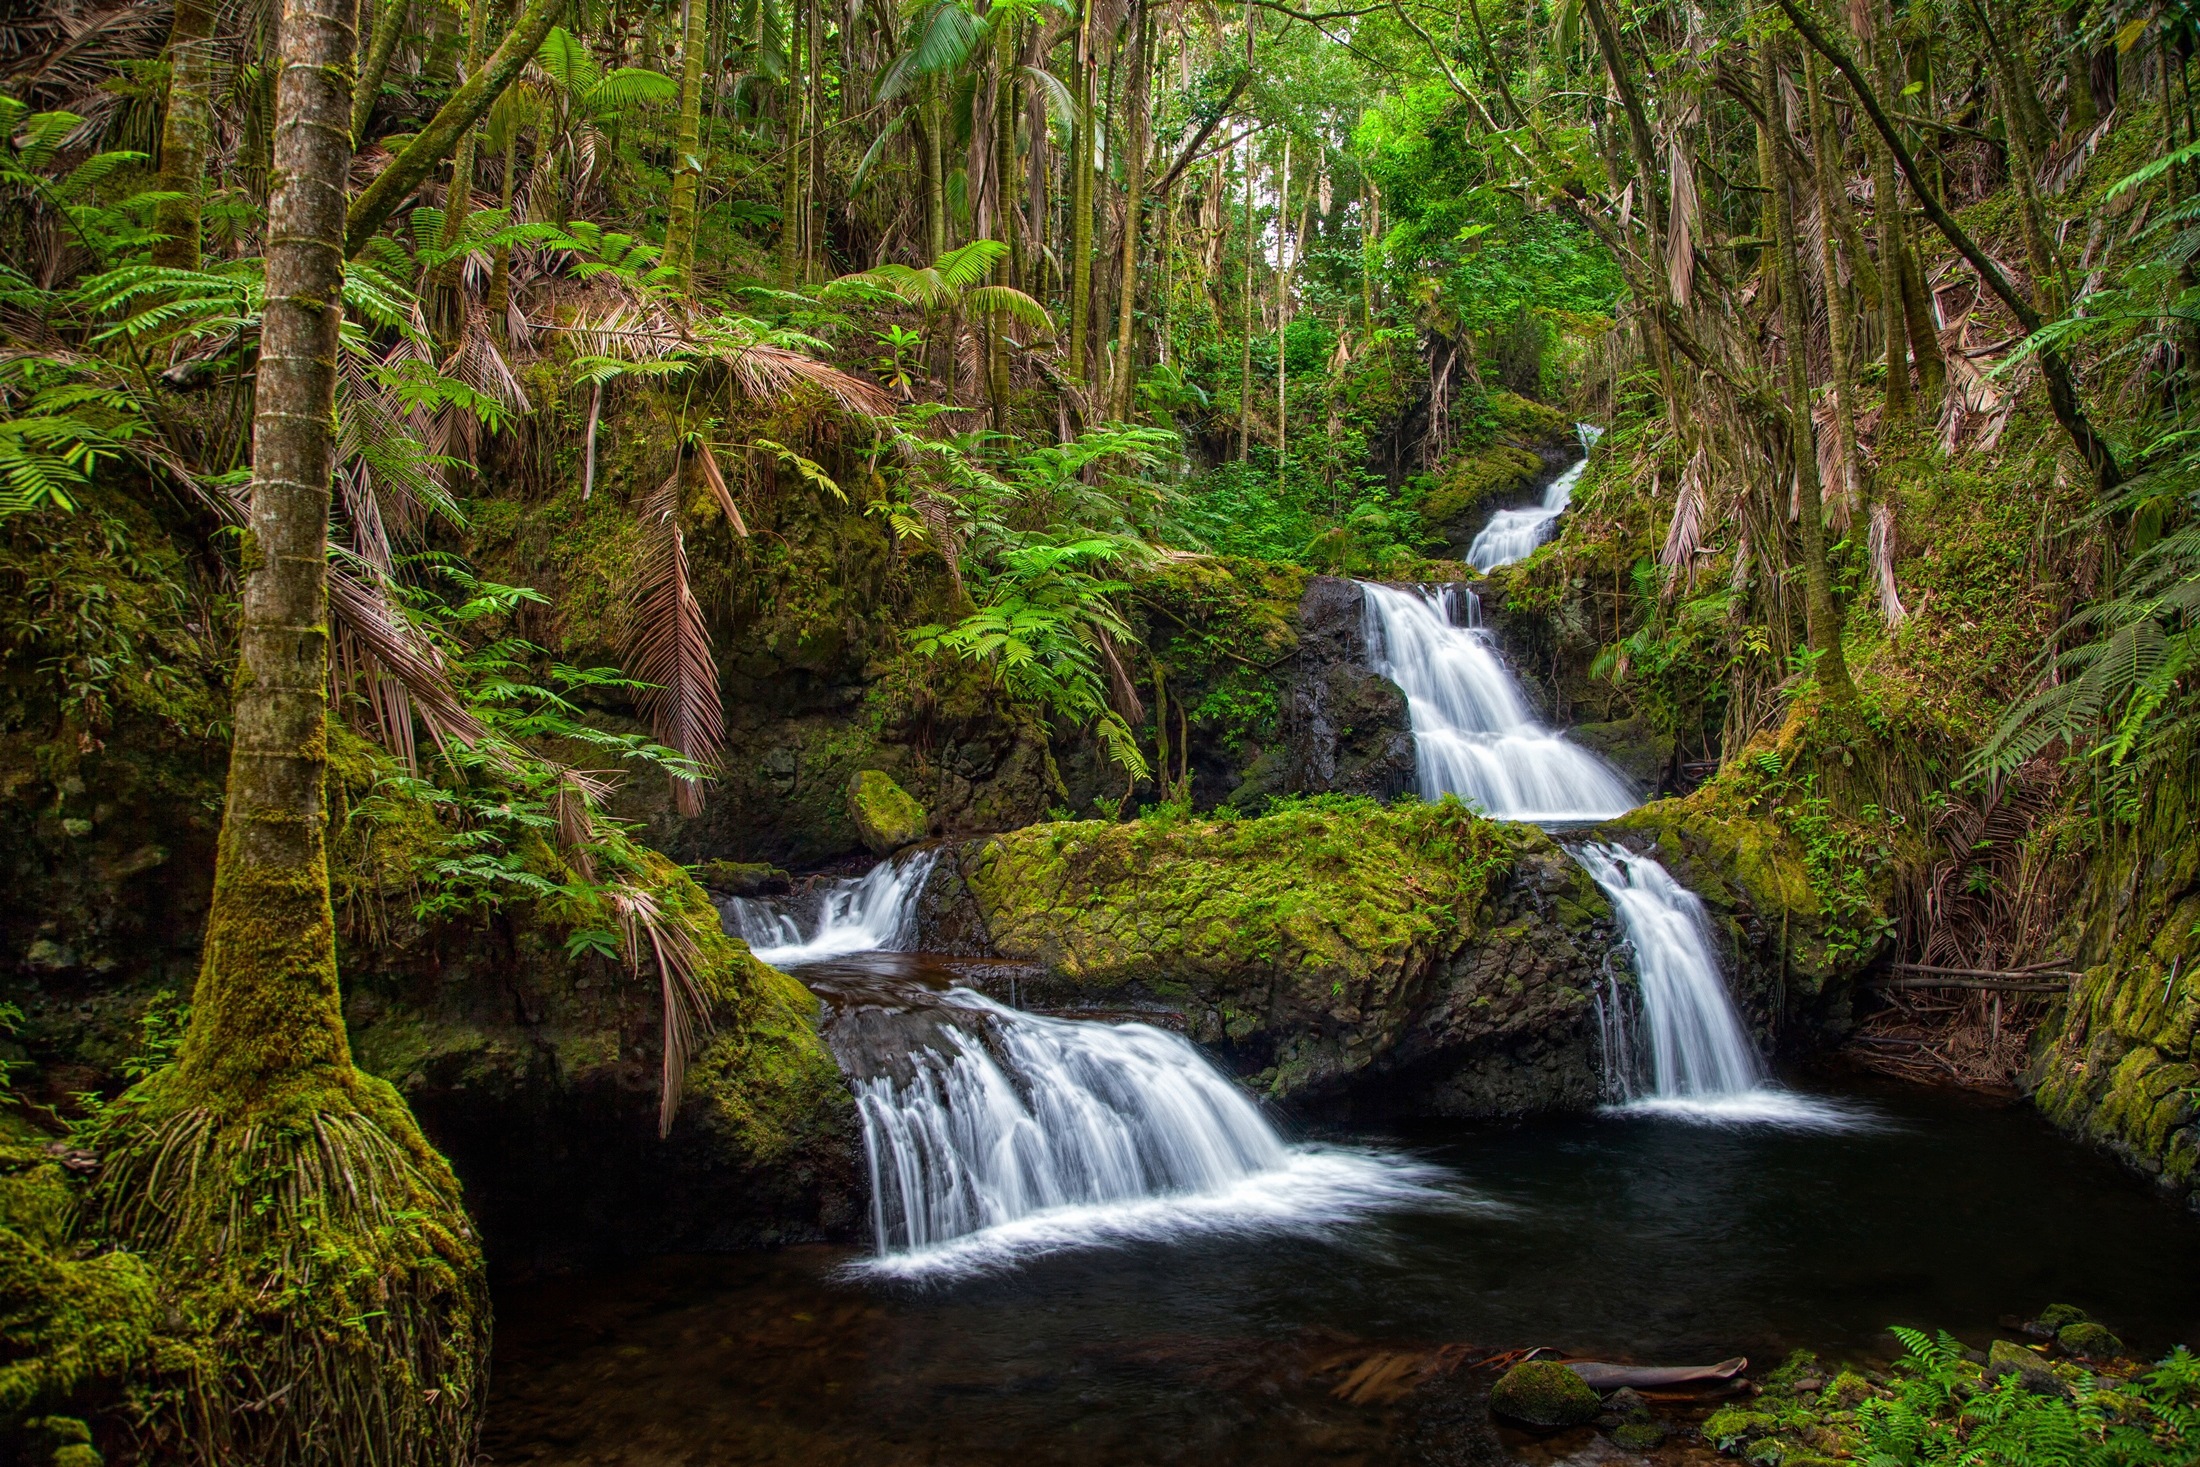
926, 798, 1615, 1115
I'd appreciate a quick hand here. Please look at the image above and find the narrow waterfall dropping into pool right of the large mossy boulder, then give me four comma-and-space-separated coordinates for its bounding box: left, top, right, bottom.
1573, 845, 1857, 1128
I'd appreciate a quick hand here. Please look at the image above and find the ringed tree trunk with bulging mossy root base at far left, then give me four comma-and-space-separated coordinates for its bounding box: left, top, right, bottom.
103, 0, 488, 1467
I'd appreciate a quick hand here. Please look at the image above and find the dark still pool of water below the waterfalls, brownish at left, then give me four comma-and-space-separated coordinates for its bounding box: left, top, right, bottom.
484, 985, 2200, 1467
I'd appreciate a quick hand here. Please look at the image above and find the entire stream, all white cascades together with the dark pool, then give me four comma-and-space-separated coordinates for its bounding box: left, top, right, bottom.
484, 433, 2200, 1467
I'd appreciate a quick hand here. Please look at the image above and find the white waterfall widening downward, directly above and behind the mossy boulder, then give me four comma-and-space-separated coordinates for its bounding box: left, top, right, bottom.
1362, 583, 1635, 825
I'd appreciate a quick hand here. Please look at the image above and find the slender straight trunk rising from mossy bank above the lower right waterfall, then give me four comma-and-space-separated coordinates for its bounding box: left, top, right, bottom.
1758, 37, 1855, 702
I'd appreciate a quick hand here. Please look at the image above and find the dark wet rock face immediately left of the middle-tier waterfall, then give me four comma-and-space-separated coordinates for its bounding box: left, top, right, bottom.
1278, 576, 1415, 798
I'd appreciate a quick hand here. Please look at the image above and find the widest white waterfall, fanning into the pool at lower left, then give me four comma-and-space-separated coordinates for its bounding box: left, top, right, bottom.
856, 988, 1456, 1276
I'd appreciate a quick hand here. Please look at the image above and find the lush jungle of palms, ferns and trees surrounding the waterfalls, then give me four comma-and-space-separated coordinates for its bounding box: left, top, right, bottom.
0, 0, 2200, 1463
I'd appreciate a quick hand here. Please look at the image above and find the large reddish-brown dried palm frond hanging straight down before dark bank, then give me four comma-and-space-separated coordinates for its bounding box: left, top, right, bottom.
627, 464, 726, 816
